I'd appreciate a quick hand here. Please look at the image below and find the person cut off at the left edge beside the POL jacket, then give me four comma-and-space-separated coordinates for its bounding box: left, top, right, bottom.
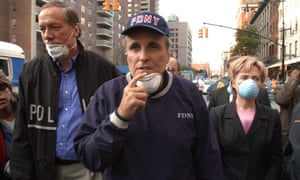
0, 70, 17, 180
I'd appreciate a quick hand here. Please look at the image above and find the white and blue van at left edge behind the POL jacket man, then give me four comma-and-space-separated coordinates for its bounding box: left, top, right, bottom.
0, 41, 25, 92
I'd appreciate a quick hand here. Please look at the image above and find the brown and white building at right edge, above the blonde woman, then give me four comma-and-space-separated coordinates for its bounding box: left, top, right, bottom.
251, 0, 300, 80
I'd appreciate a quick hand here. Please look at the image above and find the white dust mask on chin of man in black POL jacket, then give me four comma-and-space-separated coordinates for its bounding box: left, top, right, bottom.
46, 44, 70, 60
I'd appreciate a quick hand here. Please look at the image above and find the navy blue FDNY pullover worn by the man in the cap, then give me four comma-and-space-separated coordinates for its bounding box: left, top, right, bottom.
75, 74, 223, 180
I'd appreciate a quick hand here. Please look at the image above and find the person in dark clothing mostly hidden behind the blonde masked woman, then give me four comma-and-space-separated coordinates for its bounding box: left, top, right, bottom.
208, 56, 271, 110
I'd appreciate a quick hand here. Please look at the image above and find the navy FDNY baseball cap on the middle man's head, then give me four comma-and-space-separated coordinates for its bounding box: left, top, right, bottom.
121, 11, 170, 37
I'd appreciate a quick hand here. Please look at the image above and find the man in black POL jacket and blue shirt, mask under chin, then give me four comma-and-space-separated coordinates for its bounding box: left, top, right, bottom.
10, 2, 121, 180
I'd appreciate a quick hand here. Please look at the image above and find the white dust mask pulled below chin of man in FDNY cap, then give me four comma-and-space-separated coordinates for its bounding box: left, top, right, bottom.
136, 73, 162, 94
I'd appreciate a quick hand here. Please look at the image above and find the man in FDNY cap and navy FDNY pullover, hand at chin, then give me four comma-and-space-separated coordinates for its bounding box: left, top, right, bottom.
75, 12, 223, 180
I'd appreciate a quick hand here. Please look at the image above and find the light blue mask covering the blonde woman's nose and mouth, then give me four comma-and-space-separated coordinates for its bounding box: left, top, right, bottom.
238, 79, 259, 99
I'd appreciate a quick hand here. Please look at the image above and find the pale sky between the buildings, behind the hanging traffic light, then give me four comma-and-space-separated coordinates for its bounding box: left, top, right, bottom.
159, 0, 239, 69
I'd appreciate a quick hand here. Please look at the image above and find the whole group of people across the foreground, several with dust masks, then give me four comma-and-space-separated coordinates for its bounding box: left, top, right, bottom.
0, 2, 300, 180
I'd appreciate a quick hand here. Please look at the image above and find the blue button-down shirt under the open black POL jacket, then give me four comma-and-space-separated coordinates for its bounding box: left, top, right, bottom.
56, 53, 83, 160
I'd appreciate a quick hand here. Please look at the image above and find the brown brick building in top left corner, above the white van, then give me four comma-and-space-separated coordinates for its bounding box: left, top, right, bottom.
0, 0, 40, 59
